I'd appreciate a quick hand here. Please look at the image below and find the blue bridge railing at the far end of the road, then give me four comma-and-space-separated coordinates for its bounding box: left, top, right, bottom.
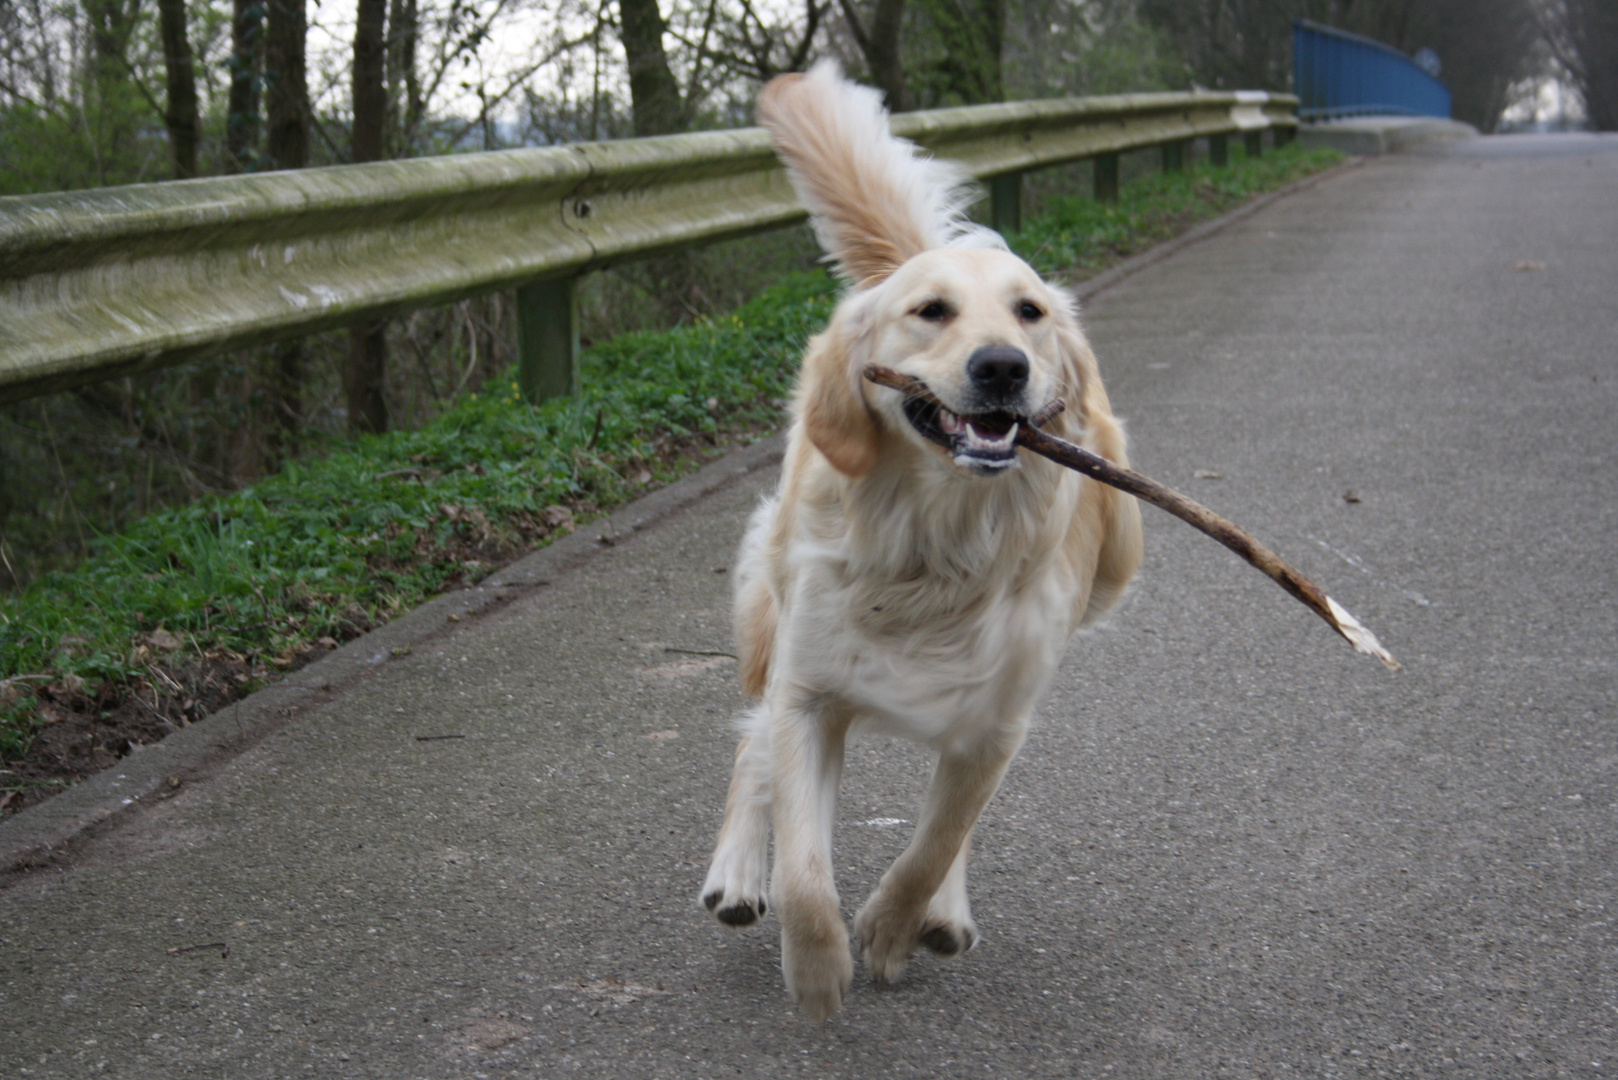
1293, 19, 1450, 120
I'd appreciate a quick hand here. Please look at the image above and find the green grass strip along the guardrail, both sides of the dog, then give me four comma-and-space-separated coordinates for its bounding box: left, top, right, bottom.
0, 141, 1335, 759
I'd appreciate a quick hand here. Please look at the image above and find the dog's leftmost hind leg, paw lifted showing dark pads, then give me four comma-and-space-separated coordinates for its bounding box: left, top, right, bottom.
701, 708, 770, 926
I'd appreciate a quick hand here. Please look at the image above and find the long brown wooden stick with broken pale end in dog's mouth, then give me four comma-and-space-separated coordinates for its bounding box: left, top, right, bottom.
866, 364, 1400, 672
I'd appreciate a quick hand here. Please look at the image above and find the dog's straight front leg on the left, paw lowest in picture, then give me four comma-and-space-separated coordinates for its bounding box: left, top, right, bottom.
772, 696, 854, 1020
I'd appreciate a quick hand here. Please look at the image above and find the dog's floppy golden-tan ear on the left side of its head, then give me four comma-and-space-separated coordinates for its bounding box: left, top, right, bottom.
798, 321, 882, 479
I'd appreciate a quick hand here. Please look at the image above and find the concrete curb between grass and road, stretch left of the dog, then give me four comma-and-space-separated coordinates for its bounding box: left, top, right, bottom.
0, 434, 786, 887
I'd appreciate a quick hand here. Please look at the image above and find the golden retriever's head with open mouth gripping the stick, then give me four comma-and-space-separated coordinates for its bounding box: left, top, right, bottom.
801, 248, 1095, 476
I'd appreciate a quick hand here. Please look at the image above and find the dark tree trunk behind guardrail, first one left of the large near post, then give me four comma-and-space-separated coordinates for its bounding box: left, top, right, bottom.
343, 0, 388, 434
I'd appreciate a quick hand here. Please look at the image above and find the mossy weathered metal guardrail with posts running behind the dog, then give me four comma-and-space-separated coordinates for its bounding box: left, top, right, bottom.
0, 91, 1298, 403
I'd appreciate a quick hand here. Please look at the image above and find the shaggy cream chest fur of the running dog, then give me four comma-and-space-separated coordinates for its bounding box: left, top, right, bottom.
760, 446, 1079, 743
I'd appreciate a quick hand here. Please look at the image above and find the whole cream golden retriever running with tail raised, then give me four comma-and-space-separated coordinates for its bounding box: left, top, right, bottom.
699, 62, 1141, 1020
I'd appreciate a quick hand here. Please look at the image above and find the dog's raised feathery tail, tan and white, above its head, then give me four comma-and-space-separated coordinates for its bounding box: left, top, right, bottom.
757, 60, 983, 288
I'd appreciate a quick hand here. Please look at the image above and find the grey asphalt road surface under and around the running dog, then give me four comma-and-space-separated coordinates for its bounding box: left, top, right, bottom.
0, 136, 1618, 1080
